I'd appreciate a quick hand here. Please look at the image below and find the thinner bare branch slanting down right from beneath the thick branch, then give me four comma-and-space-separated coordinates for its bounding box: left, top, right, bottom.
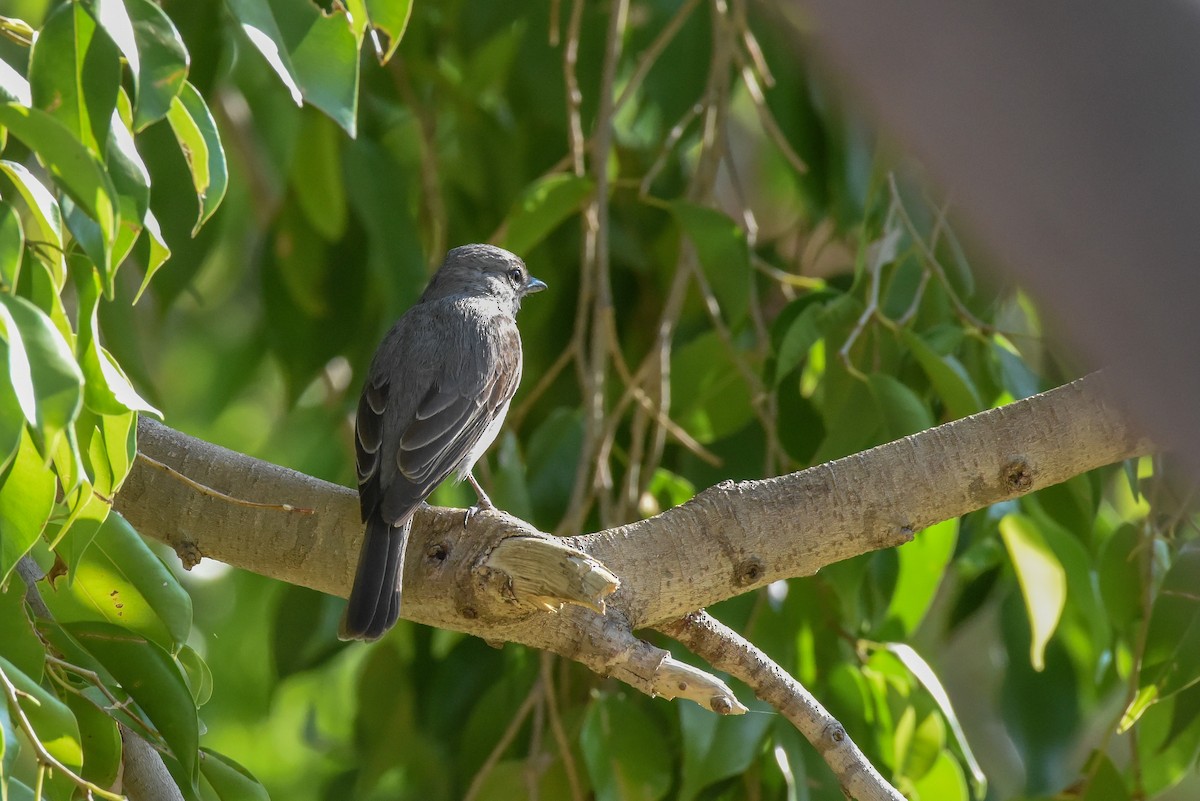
659, 612, 904, 801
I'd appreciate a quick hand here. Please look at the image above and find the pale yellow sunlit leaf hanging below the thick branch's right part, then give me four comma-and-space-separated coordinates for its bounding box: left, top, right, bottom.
1000, 514, 1067, 670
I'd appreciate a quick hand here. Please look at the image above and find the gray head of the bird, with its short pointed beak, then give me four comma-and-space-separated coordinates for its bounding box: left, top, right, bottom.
421, 245, 546, 314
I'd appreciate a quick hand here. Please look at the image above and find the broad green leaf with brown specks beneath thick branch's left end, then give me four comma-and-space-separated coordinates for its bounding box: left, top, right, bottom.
46, 512, 192, 652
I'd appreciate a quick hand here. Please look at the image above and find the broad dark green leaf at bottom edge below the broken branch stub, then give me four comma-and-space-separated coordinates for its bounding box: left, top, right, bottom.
580, 697, 676, 801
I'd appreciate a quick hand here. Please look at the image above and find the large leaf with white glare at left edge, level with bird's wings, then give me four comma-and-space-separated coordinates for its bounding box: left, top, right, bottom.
0, 294, 83, 454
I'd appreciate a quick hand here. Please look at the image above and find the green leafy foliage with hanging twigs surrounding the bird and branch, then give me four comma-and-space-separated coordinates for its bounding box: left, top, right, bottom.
0, 0, 1200, 801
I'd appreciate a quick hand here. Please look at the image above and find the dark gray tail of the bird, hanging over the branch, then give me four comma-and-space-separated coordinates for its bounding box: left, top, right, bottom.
337, 511, 413, 640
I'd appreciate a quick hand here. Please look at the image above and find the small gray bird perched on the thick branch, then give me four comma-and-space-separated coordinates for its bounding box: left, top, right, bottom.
338, 245, 546, 640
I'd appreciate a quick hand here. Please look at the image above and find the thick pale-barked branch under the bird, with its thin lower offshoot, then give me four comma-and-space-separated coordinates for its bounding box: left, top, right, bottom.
116, 375, 1150, 799
